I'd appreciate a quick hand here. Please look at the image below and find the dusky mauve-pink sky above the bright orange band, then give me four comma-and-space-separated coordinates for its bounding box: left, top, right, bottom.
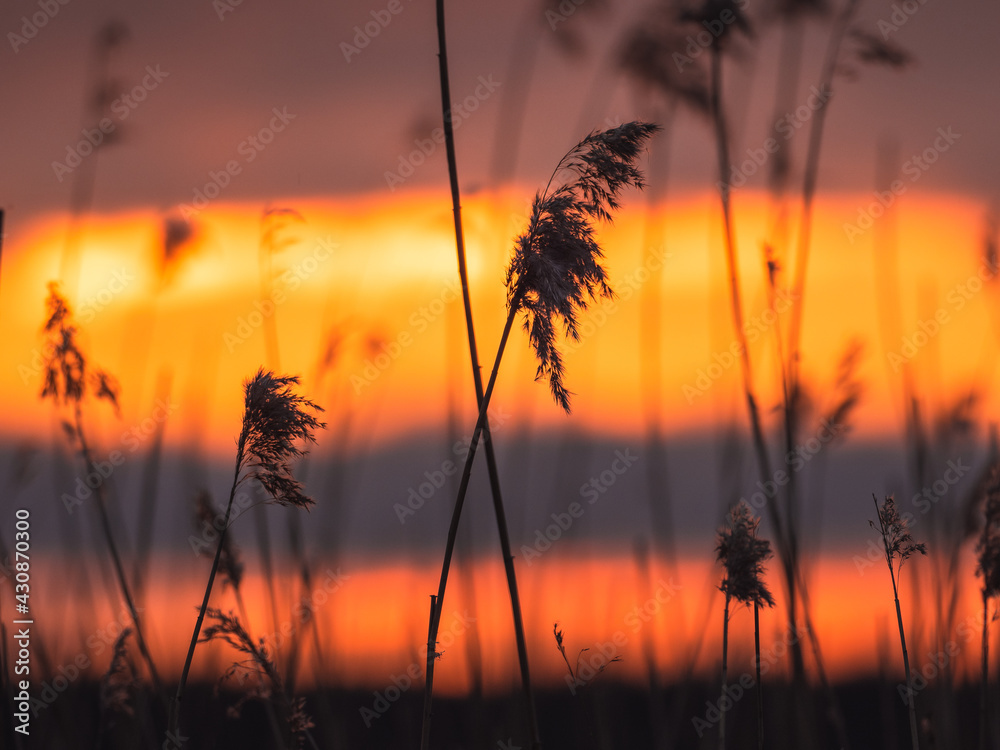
0, 0, 1000, 232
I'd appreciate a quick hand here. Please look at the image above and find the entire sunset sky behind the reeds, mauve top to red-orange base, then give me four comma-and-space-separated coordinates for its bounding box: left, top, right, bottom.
0, 0, 1000, 736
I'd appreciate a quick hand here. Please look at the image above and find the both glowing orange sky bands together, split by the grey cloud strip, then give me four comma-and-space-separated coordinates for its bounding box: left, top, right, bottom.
0, 188, 996, 690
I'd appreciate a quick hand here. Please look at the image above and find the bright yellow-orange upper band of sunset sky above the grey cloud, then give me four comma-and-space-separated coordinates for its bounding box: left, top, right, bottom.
0, 193, 995, 454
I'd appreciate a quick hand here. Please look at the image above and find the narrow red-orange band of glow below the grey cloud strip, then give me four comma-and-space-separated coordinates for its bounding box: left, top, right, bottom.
25, 547, 982, 693
